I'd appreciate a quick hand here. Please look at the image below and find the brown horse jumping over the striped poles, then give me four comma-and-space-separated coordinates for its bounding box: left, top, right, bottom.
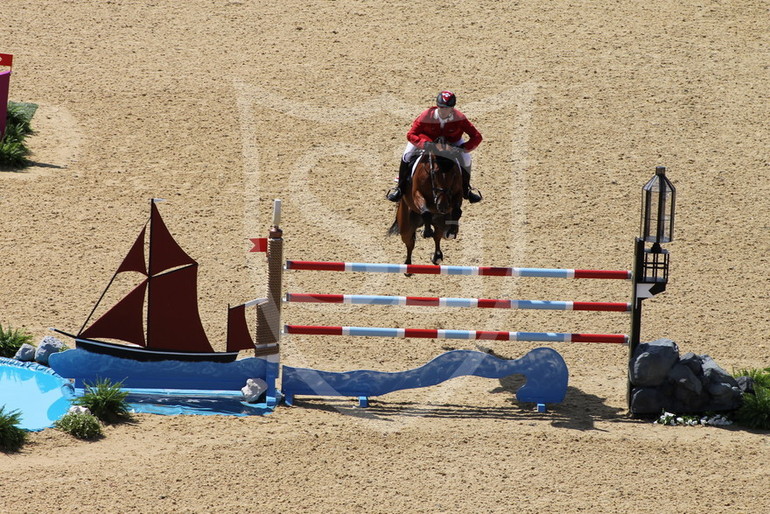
388, 141, 463, 268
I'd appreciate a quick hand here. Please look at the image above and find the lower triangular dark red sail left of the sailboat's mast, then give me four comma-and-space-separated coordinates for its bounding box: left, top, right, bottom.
79, 280, 147, 346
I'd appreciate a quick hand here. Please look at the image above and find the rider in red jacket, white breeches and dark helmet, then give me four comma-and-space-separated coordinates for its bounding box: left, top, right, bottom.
387, 91, 482, 203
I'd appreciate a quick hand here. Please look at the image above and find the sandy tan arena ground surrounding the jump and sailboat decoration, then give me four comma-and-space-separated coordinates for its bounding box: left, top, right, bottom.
0, 0, 770, 512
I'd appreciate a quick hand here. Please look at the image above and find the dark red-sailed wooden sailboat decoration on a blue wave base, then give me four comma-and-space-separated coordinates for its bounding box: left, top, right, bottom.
54, 200, 255, 362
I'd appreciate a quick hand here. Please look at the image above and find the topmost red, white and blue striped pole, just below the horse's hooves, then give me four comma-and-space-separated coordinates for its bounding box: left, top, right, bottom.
286, 260, 631, 280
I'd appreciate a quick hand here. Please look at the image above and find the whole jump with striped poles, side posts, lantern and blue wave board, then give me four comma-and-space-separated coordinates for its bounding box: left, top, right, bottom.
252, 167, 674, 411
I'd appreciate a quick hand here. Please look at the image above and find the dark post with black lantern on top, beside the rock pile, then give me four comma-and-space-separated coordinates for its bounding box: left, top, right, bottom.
627, 166, 676, 408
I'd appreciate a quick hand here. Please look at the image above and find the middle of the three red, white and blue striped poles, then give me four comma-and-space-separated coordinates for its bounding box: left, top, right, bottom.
285, 293, 631, 312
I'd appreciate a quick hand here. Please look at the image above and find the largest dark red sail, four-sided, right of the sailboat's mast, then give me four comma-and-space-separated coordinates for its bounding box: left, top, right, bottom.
147, 264, 213, 352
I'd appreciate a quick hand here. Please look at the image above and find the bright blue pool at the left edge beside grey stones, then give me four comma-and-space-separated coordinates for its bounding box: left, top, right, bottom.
0, 358, 74, 431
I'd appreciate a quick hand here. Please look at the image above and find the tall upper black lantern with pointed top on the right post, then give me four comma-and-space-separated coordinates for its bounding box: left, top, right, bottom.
641, 166, 676, 246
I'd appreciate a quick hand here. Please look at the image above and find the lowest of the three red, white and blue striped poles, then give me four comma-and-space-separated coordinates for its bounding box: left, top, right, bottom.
284, 325, 628, 344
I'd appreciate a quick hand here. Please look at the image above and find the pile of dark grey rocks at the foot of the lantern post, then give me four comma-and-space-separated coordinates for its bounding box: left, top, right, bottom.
628, 339, 752, 416
